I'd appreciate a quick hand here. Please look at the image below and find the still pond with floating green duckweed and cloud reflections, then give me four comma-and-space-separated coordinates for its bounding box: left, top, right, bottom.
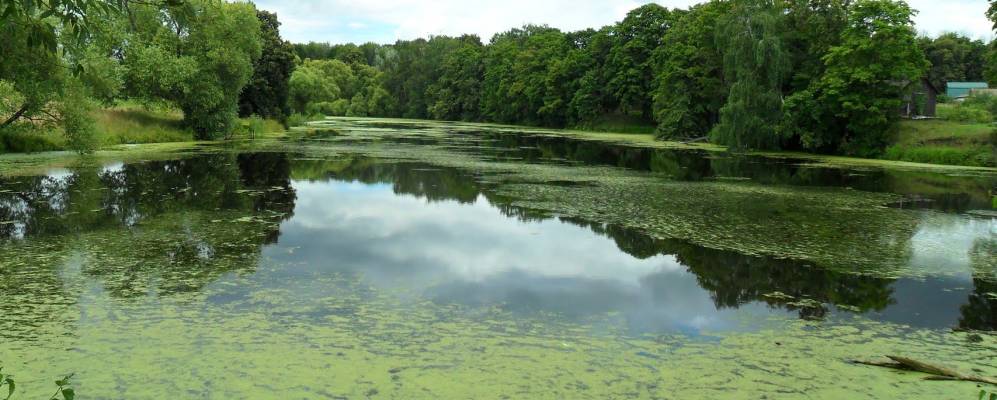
0, 119, 997, 399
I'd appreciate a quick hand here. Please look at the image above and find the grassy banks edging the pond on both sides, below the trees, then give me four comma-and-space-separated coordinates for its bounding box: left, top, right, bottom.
0, 111, 997, 171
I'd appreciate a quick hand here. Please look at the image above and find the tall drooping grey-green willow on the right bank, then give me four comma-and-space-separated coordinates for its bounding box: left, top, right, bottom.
710, 0, 790, 149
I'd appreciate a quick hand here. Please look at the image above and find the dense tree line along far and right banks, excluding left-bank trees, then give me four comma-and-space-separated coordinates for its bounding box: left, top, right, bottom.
292, 0, 997, 156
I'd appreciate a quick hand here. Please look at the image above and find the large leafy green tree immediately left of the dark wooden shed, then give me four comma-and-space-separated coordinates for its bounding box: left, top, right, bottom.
785, 0, 928, 156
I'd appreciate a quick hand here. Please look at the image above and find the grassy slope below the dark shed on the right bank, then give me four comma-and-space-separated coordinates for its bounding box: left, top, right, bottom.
884, 120, 997, 167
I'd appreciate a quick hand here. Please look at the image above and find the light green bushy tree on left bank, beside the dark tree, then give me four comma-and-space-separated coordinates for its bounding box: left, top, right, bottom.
125, 0, 261, 139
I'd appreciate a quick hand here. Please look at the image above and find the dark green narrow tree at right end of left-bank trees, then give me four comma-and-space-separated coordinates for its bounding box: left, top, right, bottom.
239, 10, 294, 121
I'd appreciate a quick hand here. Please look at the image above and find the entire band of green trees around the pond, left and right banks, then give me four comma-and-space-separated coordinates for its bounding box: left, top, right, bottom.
0, 0, 997, 156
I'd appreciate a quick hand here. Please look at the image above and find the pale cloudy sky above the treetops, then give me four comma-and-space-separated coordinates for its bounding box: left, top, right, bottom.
255, 0, 993, 43
